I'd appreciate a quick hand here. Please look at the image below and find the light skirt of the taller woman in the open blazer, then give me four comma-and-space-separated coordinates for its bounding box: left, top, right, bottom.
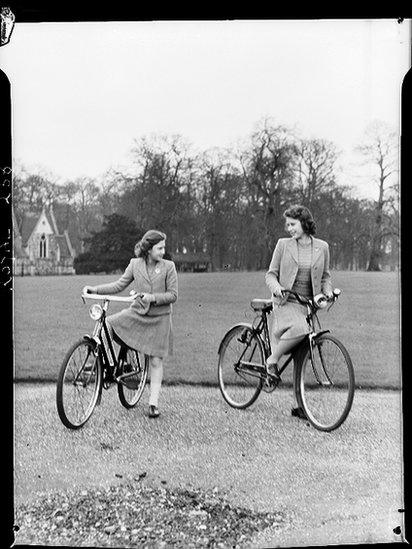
271, 301, 310, 340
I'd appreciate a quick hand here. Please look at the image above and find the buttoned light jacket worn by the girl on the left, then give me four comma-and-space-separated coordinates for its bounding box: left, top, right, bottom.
94, 257, 178, 316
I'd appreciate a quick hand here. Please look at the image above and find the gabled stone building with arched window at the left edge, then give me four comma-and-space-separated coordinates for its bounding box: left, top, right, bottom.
12, 207, 75, 276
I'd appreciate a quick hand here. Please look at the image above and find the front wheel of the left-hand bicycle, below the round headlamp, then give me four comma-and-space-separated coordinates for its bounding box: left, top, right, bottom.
56, 339, 102, 429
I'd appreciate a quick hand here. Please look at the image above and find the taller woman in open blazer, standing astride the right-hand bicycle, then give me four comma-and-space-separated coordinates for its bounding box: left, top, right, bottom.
265, 205, 332, 418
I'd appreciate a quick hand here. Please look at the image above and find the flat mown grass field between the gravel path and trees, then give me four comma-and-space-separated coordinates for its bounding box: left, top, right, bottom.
13, 271, 401, 388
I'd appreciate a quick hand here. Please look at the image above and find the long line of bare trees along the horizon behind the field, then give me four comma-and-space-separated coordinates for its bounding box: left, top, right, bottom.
13, 119, 399, 271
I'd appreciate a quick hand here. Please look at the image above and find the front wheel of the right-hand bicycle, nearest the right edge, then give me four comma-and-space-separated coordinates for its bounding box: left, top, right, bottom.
297, 334, 355, 431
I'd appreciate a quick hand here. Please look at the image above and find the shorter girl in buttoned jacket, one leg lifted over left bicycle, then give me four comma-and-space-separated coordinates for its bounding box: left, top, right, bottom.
84, 230, 178, 418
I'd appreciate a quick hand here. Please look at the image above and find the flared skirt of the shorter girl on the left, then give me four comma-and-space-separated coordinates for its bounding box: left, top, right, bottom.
107, 308, 173, 358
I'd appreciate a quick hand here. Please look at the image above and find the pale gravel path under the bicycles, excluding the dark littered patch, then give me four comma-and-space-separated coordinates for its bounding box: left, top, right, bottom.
15, 384, 403, 547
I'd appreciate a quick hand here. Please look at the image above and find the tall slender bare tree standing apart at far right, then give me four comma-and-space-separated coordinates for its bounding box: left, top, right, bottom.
355, 121, 398, 271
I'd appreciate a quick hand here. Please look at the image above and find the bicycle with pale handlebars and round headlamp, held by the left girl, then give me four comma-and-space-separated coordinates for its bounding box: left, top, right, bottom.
56, 291, 149, 429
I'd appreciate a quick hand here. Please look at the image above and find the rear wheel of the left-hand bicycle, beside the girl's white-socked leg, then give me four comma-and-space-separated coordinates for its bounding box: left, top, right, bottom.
117, 347, 149, 408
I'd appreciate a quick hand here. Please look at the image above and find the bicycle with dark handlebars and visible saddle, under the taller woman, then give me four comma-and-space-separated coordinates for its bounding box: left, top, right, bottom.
218, 289, 355, 431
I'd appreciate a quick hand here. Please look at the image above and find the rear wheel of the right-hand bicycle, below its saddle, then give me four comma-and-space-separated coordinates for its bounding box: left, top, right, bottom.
218, 325, 265, 408
